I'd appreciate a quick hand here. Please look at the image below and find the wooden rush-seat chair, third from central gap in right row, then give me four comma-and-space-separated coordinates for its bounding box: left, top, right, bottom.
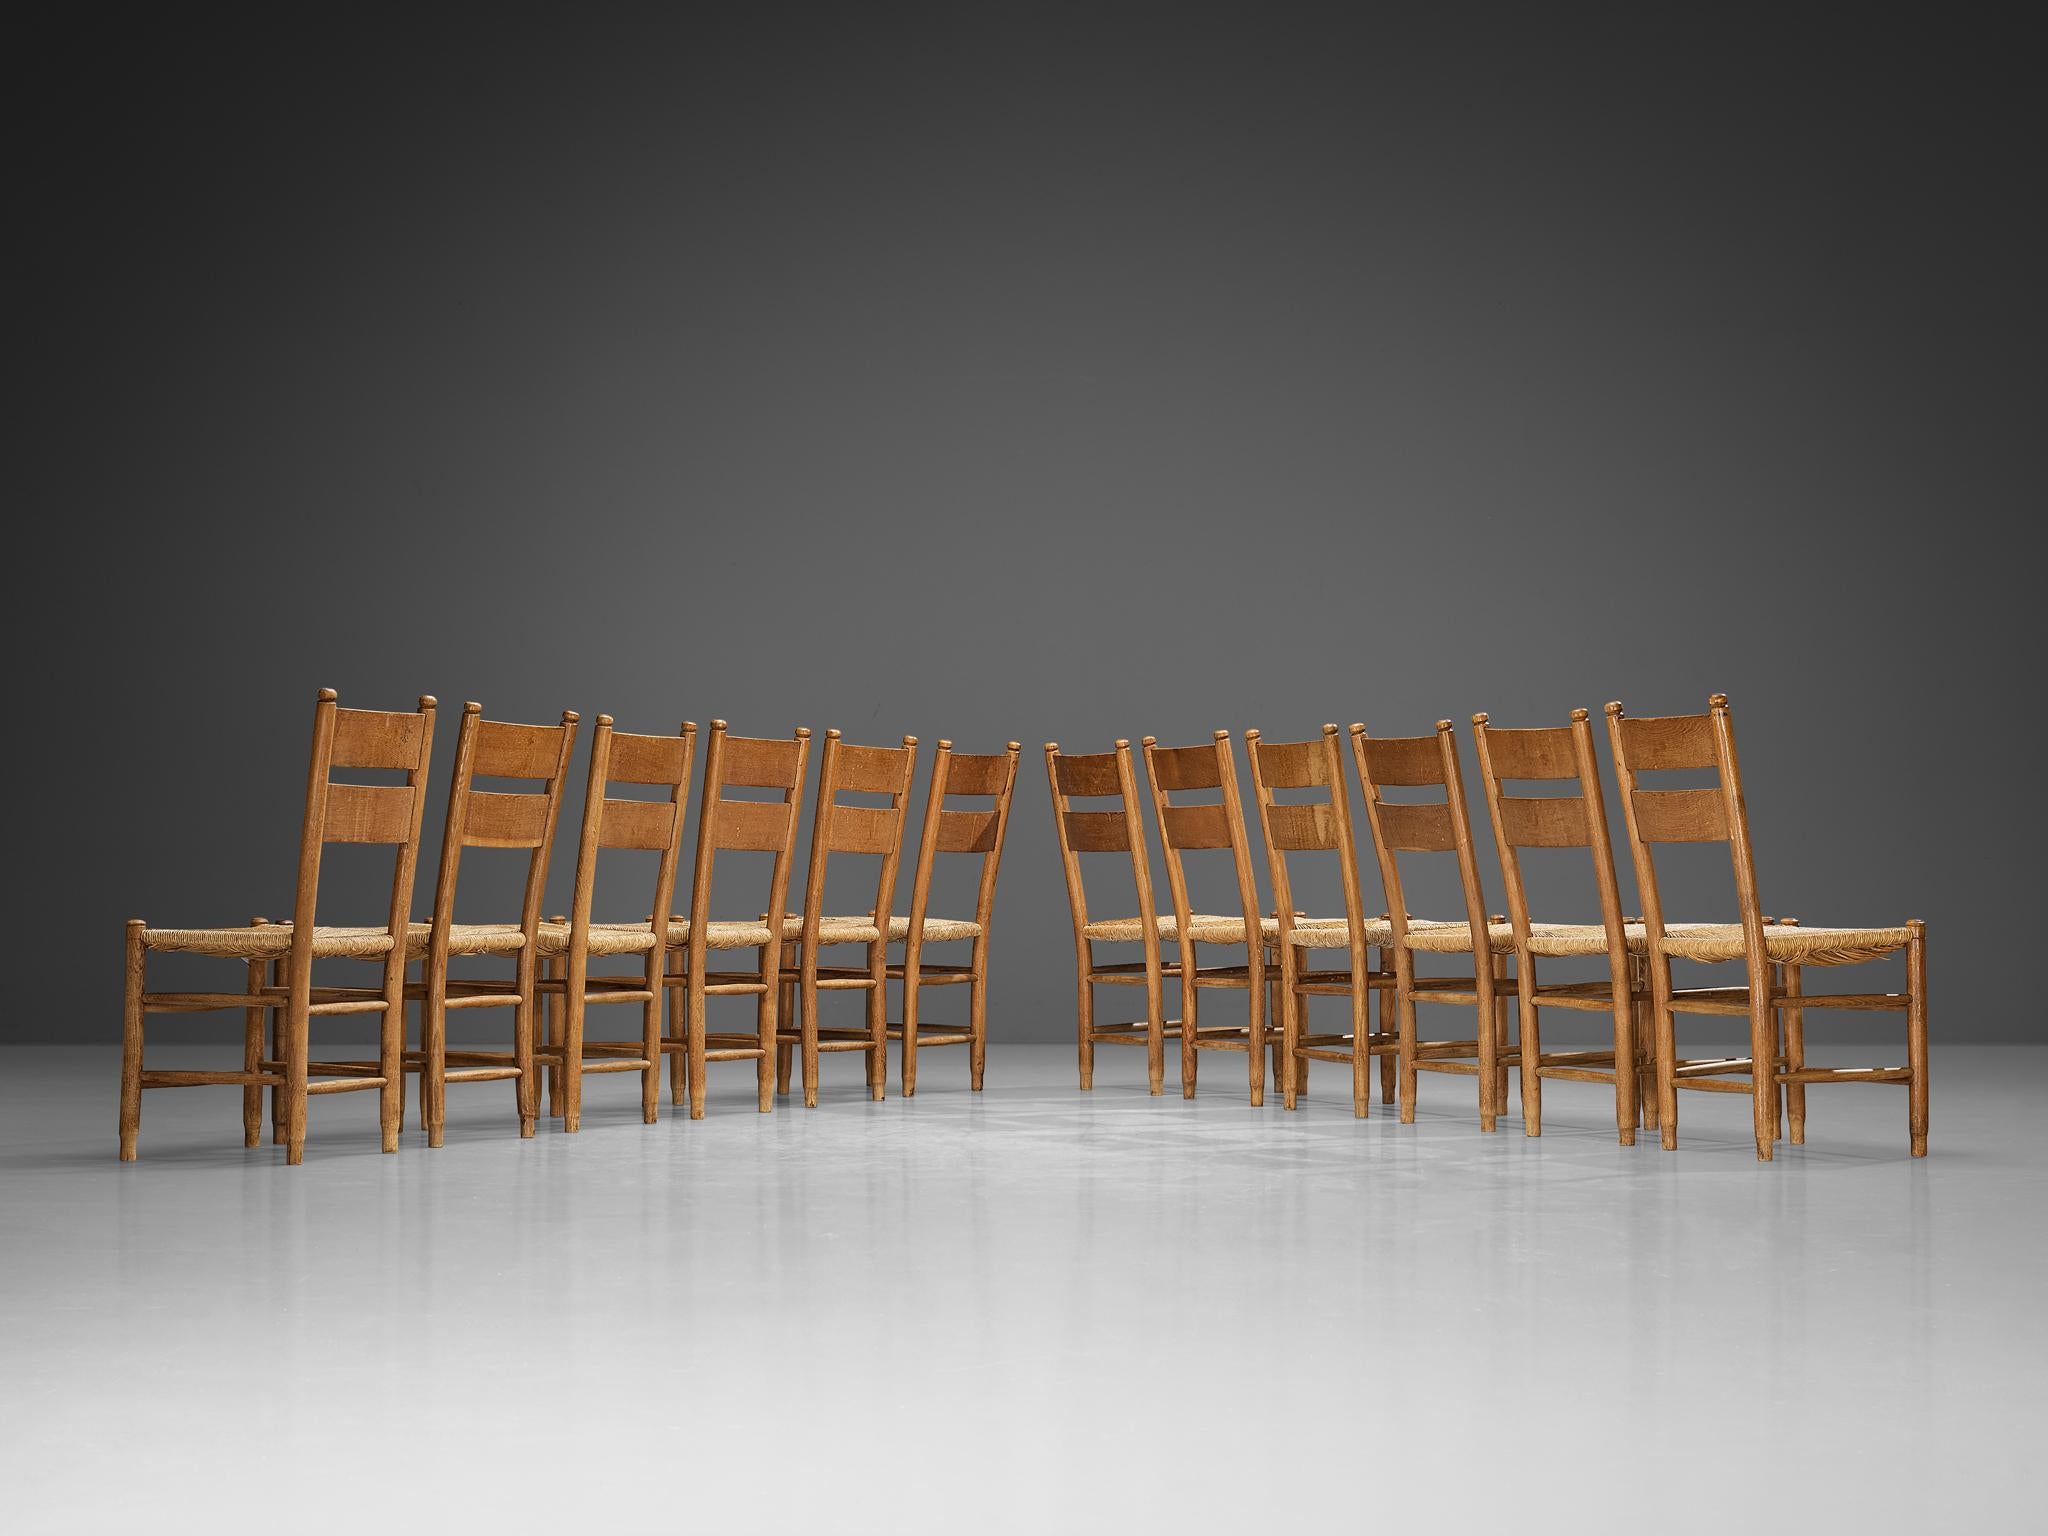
1245, 725, 1401, 1118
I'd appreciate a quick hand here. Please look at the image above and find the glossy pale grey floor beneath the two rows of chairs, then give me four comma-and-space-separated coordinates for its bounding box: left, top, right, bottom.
0, 1047, 2048, 1532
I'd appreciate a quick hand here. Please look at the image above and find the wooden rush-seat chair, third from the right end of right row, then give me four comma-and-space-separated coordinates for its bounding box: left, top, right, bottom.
1352, 721, 1518, 1130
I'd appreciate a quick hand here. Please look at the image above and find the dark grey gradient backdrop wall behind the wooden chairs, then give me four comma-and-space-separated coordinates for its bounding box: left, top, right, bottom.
16, 4, 2044, 1040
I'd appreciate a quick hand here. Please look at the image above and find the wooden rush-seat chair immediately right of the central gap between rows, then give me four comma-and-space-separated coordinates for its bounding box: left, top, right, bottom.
1044, 741, 1180, 1094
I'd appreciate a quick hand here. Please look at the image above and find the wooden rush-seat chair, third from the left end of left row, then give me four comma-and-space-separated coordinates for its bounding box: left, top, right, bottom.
532, 715, 696, 1135
